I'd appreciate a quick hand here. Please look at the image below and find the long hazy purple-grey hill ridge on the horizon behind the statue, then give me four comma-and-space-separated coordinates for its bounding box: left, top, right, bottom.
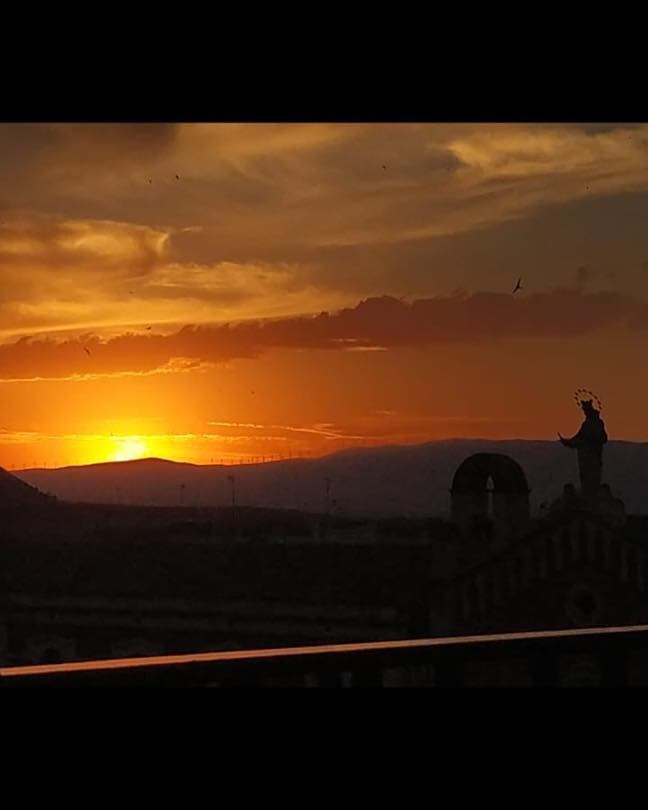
16, 439, 648, 518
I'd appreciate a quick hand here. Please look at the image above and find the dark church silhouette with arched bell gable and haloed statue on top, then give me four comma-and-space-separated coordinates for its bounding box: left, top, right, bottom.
440, 401, 636, 633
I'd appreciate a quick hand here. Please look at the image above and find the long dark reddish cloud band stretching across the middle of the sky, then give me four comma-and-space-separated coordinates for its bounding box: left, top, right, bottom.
0, 289, 648, 380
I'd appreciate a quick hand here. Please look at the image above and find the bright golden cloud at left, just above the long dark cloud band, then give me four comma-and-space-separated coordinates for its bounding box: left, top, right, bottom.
0, 212, 346, 336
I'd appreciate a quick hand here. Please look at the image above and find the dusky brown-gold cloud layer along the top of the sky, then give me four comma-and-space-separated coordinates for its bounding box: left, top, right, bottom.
5, 124, 648, 263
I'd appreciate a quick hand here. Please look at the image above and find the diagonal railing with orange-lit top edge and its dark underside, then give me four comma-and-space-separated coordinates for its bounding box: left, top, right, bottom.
0, 625, 648, 687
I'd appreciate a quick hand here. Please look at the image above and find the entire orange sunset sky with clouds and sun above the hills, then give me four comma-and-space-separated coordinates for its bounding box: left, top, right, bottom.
0, 124, 648, 469
